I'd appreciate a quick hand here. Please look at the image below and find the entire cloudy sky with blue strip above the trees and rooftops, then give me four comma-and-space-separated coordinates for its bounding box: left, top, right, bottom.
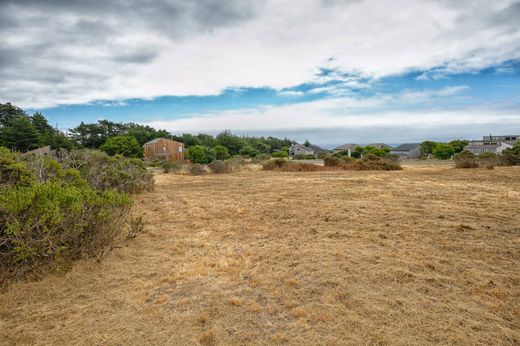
0, 0, 520, 147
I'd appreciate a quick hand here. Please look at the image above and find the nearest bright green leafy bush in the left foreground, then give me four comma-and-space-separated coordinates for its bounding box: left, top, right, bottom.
0, 182, 131, 282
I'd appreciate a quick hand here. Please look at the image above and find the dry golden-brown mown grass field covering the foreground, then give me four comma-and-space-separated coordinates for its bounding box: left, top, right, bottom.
0, 165, 520, 345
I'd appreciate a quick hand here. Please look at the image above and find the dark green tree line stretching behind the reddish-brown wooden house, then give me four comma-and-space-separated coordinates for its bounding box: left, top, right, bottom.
0, 103, 295, 163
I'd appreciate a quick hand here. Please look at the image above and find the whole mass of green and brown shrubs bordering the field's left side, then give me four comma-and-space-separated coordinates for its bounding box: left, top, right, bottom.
0, 148, 138, 284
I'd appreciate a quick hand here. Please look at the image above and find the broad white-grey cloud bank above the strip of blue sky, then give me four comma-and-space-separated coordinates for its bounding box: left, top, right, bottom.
0, 0, 520, 107
